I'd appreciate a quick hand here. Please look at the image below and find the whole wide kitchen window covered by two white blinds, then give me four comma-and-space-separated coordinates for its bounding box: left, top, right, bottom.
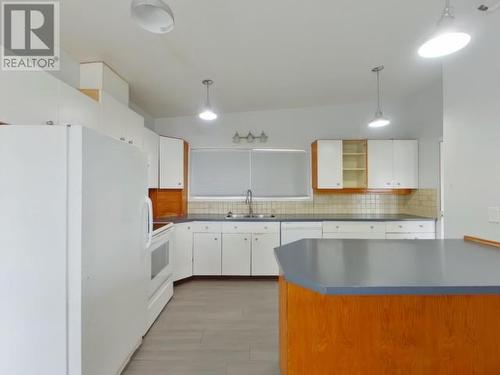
190, 149, 311, 200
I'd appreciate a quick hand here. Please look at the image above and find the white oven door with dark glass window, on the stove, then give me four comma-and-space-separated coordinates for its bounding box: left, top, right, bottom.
149, 230, 173, 297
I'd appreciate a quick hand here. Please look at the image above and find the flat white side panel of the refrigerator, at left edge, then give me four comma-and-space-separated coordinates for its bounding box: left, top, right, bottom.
0, 126, 67, 375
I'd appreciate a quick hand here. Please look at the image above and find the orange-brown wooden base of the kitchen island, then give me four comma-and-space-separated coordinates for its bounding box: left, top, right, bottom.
279, 276, 500, 375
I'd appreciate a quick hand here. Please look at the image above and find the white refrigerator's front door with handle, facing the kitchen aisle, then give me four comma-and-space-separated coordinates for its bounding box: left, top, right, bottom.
74, 128, 148, 375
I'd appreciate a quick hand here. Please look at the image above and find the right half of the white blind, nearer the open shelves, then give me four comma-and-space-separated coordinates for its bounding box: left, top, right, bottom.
251, 150, 310, 198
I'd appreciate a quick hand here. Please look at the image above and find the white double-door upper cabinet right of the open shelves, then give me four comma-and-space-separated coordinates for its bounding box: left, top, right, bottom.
368, 140, 418, 189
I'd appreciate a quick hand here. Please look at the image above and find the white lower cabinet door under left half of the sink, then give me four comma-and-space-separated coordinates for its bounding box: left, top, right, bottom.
222, 233, 252, 276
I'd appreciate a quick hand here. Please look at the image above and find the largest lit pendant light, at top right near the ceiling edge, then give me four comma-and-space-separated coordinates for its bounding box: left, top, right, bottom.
418, 0, 471, 58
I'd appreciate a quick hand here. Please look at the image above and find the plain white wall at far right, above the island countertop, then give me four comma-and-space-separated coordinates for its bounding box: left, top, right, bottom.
443, 11, 500, 241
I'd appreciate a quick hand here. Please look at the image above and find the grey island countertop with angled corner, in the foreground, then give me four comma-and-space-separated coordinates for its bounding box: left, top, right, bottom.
275, 239, 500, 295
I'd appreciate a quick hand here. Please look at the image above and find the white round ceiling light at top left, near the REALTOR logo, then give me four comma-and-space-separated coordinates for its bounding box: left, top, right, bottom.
131, 0, 174, 34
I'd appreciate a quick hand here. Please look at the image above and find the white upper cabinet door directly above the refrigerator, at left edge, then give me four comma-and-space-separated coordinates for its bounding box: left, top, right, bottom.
0, 70, 59, 125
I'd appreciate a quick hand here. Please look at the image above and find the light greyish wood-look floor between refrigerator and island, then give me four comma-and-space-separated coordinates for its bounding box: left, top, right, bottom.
123, 280, 279, 375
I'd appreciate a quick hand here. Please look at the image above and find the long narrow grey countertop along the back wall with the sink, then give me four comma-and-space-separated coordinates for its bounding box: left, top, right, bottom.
155, 214, 435, 223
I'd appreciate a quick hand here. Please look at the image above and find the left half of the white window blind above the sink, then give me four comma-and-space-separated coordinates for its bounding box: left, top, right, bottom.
190, 149, 250, 197
